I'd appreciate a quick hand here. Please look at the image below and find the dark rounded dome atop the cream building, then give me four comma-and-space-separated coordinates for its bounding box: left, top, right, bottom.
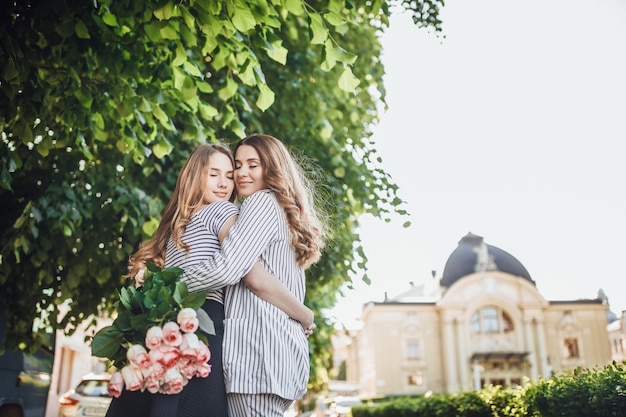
441, 233, 535, 287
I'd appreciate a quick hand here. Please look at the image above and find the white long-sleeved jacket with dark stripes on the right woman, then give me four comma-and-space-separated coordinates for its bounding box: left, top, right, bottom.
181, 190, 310, 400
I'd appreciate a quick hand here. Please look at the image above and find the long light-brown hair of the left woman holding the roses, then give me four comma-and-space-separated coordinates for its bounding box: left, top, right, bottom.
125, 143, 235, 278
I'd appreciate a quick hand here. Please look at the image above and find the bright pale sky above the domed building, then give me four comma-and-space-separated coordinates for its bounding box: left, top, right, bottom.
326, 0, 626, 327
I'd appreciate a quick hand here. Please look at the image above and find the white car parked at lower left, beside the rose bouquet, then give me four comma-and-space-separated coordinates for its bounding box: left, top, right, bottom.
59, 373, 111, 417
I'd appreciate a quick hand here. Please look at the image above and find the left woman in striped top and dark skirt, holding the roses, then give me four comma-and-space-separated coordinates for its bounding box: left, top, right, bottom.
107, 144, 313, 417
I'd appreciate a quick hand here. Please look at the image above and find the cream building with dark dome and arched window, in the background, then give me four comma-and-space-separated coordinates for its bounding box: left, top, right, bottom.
346, 233, 625, 397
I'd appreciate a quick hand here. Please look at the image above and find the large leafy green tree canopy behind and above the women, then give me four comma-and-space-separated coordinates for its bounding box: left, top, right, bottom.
0, 0, 443, 386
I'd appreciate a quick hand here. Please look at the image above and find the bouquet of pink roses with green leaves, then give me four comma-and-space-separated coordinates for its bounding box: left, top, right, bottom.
91, 264, 214, 397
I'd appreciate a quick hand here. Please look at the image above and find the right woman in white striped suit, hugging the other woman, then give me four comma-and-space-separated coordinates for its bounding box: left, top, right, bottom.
181, 134, 324, 417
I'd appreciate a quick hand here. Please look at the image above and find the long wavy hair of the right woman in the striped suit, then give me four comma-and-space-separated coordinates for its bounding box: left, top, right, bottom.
233, 134, 325, 269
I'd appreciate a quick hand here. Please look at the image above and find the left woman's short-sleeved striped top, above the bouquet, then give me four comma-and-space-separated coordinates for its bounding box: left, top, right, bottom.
165, 201, 238, 304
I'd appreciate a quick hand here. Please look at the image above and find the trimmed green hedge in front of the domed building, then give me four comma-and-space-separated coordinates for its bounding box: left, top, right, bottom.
352, 362, 626, 417
